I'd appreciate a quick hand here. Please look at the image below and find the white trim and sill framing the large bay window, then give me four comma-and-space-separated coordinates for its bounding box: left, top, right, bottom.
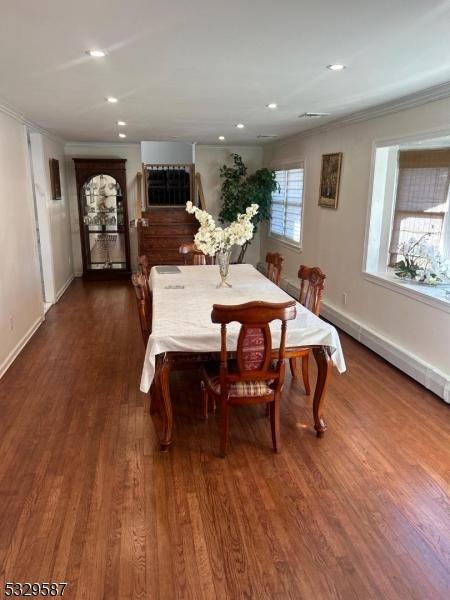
362, 128, 450, 313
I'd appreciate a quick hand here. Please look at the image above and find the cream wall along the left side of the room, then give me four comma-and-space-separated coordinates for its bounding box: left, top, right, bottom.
0, 107, 73, 377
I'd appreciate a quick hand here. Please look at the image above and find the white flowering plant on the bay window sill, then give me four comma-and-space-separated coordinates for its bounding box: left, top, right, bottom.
394, 233, 450, 285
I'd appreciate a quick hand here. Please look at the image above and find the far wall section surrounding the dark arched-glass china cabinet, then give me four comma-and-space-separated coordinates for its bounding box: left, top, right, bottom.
65, 143, 142, 275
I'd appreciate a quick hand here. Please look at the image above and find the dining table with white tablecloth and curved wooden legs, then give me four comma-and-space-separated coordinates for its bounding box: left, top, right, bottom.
140, 264, 345, 451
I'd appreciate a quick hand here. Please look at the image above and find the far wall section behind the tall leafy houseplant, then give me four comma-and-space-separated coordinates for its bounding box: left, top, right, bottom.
195, 145, 263, 264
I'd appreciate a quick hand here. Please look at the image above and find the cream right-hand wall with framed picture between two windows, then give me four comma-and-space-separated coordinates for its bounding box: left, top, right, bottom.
261, 99, 450, 393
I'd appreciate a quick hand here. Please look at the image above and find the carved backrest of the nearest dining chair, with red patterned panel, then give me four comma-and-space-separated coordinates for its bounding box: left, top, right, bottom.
211, 300, 296, 389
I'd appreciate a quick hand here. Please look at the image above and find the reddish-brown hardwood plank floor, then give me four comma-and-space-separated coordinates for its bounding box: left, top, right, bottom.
0, 280, 450, 600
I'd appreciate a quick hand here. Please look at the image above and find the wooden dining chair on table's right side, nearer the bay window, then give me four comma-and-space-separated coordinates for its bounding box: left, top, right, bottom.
285, 265, 326, 396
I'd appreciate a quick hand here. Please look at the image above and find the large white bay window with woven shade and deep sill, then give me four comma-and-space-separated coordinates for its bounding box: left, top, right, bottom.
364, 140, 450, 312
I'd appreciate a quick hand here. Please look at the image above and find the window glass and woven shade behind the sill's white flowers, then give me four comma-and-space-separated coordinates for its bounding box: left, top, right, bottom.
389, 149, 450, 265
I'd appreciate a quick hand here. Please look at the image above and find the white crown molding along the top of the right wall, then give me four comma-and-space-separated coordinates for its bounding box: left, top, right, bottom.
276, 81, 450, 145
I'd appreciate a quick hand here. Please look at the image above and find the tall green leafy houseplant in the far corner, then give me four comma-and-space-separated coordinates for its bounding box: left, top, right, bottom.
219, 154, 278, 263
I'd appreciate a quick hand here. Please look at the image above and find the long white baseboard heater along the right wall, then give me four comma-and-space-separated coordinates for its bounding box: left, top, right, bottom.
258, 263, 450, 404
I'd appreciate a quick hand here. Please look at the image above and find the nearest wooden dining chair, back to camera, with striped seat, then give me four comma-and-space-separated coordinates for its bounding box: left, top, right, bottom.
202, 301, 296, 457
